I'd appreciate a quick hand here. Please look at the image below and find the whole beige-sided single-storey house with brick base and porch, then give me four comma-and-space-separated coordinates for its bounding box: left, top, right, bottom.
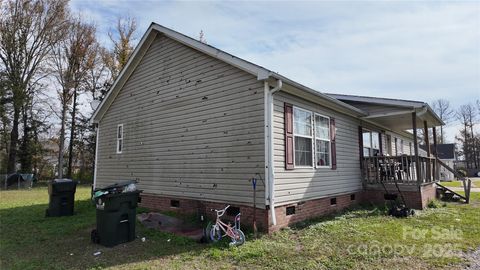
92, 24, 443, 231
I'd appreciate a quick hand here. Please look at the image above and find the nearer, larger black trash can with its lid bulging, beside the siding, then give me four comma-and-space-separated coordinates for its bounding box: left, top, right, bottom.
91, 185, 141, 247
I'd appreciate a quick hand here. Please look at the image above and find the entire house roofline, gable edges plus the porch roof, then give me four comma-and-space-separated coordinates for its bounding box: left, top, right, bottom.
90, 23, 443, 130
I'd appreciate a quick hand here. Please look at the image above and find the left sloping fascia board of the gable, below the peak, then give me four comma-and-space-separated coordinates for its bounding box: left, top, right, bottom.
90, 27, 157, 124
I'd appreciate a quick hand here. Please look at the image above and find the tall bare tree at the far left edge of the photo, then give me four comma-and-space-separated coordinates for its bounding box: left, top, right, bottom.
0, 0, 68, 172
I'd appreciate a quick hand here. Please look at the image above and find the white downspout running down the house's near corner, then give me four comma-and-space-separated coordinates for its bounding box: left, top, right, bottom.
265, 80, 283, 225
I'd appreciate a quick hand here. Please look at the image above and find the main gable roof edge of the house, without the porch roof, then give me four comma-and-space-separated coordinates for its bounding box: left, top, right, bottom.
90, 23, 367, 123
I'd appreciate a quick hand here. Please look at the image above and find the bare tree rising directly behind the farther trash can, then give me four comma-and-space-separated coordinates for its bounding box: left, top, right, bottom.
53, 19, 96, 178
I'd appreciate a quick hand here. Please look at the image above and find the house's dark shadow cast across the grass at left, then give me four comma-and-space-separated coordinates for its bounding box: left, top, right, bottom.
0, 196, 232, 269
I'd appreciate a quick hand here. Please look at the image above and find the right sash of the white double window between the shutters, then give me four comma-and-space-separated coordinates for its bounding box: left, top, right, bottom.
315, 114, 330, 167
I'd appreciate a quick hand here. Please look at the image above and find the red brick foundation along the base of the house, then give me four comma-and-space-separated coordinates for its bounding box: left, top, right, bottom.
140, 184, 436, 233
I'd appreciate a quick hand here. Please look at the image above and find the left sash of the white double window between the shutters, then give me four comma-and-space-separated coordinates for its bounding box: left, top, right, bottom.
293, 108, 313, 167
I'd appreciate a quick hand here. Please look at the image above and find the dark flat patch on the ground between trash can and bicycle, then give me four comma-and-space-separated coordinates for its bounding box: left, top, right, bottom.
137, 212, 208, 242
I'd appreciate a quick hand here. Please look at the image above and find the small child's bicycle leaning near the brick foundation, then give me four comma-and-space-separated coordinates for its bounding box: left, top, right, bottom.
210, 205, 245, 246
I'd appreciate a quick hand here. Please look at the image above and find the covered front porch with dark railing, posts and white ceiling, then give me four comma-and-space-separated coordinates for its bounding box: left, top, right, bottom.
361, 105, 443, 188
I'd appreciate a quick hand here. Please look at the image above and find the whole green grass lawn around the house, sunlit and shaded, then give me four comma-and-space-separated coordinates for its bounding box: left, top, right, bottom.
0, 187, 480, 269
